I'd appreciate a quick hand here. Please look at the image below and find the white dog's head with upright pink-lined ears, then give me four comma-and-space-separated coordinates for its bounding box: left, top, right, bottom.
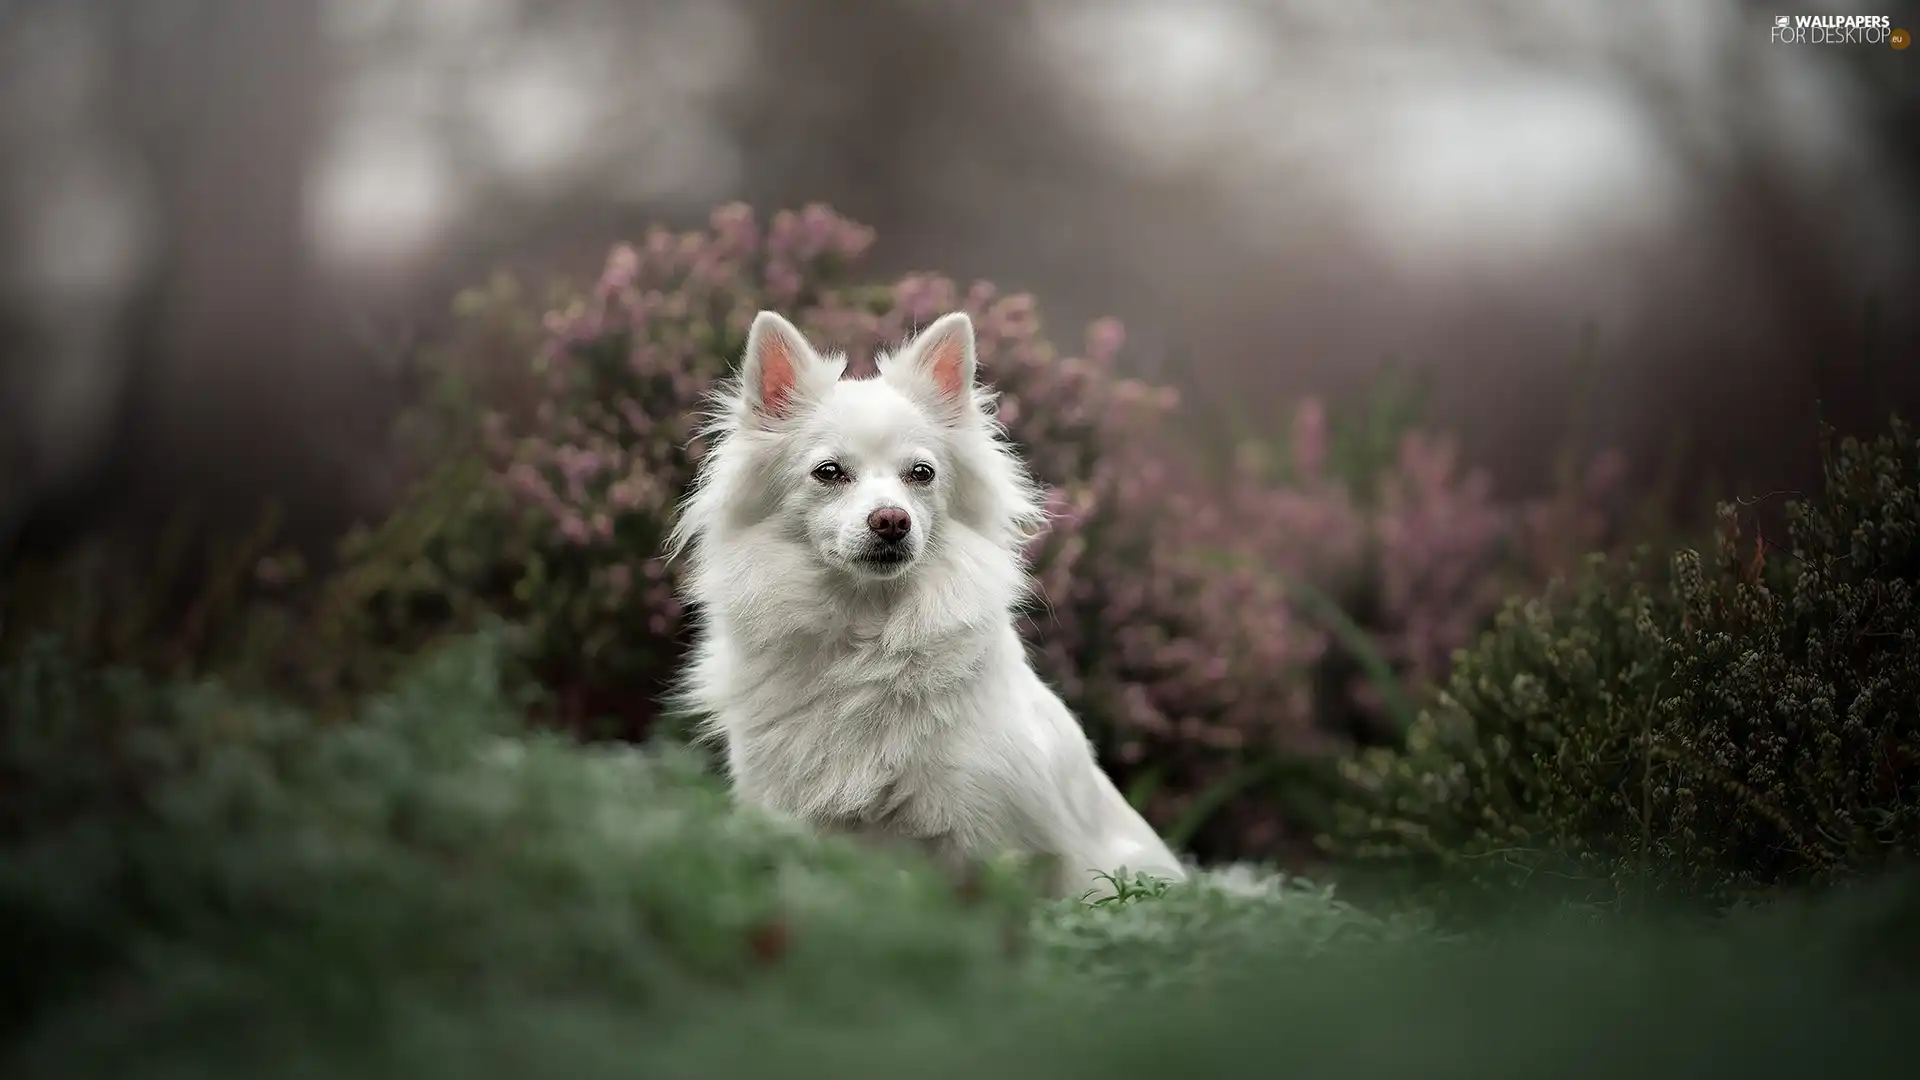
682, 311, 1039, 580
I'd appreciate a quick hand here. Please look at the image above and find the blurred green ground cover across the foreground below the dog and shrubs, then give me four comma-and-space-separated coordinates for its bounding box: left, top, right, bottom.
0, 638, 1920, 1080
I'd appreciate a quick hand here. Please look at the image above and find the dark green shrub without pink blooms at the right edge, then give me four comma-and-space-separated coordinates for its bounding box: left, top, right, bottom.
1325, 421, 1920, 903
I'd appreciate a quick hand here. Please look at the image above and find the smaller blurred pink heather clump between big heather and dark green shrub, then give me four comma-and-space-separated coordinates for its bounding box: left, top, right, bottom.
1235, 388, 1624, 757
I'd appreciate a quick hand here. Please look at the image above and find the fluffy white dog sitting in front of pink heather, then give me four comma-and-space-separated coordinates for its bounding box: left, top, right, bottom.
668, 311, 1185, 892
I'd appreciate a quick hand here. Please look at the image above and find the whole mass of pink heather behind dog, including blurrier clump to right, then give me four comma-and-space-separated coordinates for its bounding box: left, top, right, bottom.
315, 206, 1635, 853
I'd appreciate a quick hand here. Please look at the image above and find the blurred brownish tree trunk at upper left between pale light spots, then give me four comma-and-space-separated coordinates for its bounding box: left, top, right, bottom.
117, 0, 323, 518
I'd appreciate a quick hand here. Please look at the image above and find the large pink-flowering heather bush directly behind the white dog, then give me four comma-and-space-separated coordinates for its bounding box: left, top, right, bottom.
322, 208, 1344, 841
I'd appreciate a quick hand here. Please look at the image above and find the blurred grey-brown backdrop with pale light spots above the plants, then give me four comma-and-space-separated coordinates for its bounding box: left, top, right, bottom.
0, 0, 1920, 546
